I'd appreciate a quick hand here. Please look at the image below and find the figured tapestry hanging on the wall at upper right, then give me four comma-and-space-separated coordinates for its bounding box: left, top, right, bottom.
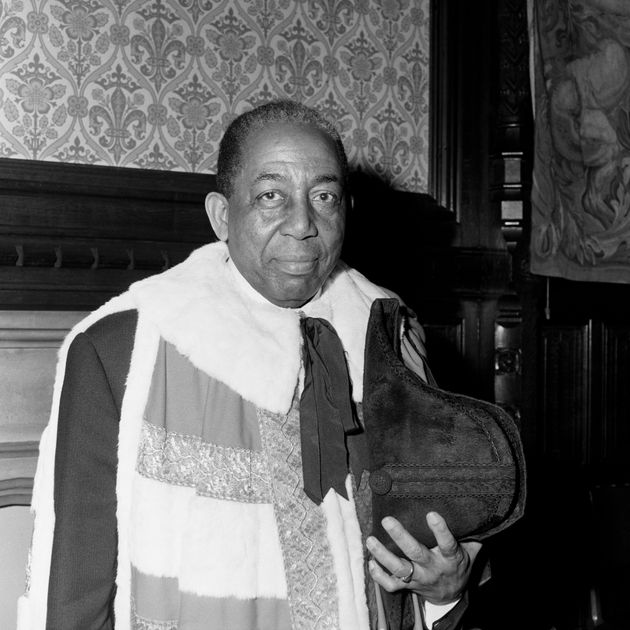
529, 0, 630, 282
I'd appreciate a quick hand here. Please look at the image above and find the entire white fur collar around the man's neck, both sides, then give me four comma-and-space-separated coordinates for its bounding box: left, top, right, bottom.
130, 242, 387, 413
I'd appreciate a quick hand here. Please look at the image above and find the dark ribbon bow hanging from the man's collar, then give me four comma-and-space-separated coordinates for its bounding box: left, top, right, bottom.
300, 317, 360, 505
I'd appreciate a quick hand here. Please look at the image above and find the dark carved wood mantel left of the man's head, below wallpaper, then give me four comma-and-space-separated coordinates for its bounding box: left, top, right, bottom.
0, 159, 215, 310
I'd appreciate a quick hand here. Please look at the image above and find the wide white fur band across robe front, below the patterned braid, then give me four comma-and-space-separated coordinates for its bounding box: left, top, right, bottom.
131, 482, 287, 599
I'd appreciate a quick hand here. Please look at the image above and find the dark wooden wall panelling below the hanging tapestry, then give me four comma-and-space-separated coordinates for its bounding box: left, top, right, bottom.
528, 288, 630, 480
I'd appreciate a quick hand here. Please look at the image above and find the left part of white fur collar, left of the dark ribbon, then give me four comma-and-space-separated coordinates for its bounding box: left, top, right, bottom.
130, 242, 301, 413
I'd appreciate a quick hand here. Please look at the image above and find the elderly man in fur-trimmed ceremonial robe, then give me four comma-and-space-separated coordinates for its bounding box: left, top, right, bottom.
19, 101, 479, 630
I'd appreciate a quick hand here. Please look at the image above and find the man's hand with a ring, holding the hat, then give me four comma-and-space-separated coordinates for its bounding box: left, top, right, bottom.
367, 512, 481, 604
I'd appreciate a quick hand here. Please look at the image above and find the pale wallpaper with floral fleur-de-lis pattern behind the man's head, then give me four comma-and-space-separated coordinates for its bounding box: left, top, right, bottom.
0, 0, 430, 191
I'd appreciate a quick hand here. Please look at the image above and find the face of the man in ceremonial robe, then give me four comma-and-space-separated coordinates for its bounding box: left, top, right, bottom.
222, 123, 346, 308
